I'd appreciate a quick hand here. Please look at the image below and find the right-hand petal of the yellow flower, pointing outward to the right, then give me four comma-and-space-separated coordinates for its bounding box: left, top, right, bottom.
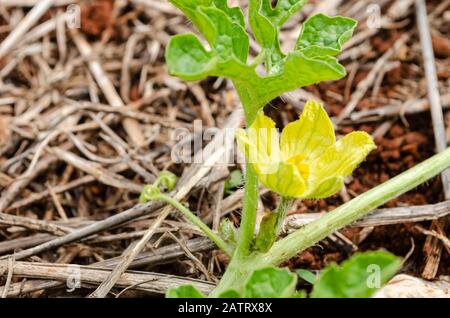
308, 131, 376, 195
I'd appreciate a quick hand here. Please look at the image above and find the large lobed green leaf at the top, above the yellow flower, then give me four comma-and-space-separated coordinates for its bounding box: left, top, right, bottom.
166, 0, 356, 123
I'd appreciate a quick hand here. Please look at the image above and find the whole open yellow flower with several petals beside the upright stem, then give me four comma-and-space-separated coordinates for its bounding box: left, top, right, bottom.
236, 101, 376, 199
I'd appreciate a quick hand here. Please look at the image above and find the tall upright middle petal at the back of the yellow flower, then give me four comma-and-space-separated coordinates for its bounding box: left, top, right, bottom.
280, 100, 336, 162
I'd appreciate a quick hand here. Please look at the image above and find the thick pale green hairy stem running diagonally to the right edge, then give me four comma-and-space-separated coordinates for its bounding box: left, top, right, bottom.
263, 148, 450, 265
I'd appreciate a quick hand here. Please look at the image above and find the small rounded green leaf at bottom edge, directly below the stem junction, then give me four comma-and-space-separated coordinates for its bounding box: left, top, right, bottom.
243, 267, 297, 298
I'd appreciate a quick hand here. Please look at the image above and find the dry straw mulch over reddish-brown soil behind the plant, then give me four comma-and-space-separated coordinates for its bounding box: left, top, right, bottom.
0, 0, 450, 297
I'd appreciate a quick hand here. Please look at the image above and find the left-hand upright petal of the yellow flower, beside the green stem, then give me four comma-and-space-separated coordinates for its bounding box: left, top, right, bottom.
236, 112, 280, 174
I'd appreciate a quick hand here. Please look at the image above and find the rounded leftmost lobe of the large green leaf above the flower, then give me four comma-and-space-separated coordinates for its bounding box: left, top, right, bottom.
166, 33, 215, 80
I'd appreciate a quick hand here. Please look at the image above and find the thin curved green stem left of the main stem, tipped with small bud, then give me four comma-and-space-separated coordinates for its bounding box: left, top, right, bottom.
152, 193, 232, 256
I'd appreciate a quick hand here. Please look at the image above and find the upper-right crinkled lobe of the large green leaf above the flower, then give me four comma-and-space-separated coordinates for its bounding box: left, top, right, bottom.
295, 13, 357, 57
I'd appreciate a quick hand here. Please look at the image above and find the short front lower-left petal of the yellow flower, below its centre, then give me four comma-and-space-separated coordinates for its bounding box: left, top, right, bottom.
257, 163, 306, 198
